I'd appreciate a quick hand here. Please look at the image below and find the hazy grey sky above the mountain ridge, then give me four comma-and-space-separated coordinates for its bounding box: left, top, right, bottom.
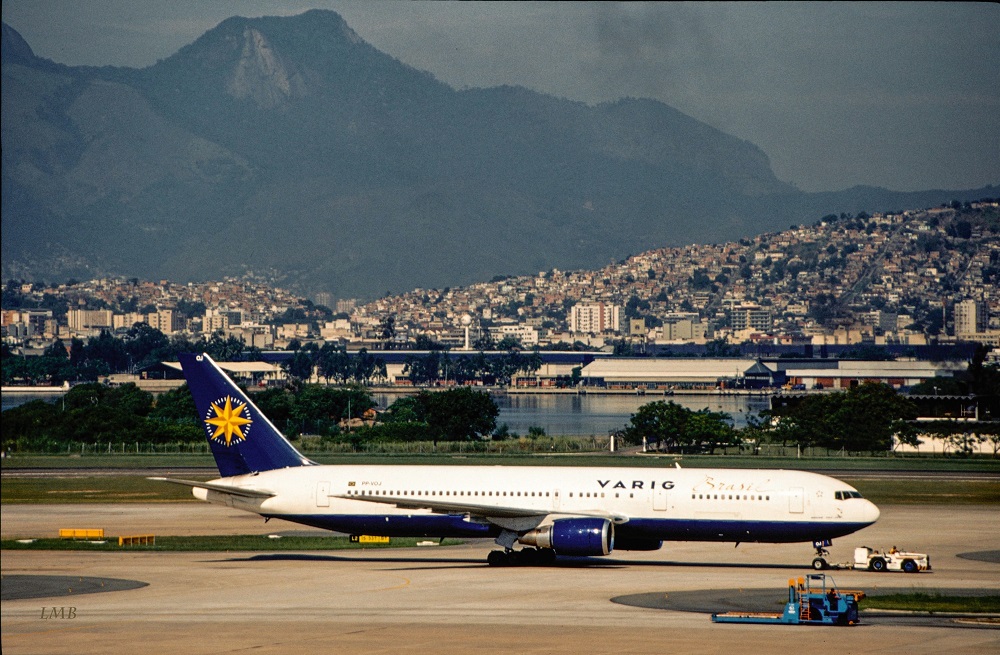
2, 0, 1000, 191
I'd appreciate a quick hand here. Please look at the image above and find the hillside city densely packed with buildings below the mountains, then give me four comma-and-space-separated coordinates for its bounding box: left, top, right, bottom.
2, 199, 1000, 354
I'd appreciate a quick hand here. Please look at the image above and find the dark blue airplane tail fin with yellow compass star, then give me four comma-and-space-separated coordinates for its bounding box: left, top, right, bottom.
178, 354, 315, 478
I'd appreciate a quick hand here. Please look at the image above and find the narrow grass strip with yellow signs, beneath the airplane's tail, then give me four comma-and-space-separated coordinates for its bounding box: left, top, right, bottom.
0, 535, 463, 552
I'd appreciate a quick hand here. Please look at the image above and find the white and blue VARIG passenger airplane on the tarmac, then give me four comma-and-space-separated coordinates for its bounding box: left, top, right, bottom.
154, 354, 879, 568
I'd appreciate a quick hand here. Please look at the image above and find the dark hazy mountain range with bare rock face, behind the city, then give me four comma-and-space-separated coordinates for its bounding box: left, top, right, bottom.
0, 10, 995, 298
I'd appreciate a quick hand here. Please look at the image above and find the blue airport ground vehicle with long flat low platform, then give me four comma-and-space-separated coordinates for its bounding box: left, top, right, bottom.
712, 573, 865, 625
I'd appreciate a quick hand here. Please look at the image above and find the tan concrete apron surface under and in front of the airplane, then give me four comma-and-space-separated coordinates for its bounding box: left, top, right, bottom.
0, 503, 1000, 655
